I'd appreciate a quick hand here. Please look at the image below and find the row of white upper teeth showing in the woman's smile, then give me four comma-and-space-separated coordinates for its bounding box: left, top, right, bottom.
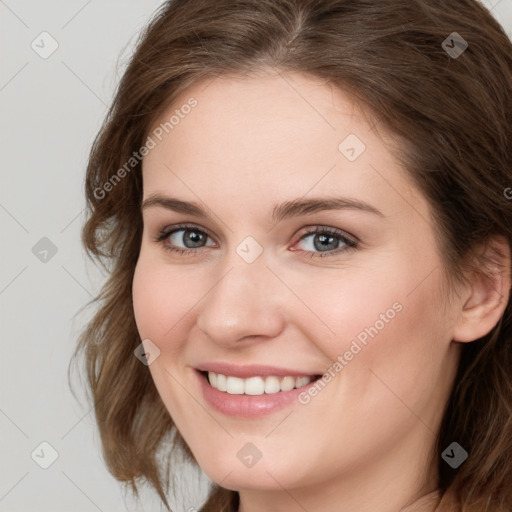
208, 372, 313, 395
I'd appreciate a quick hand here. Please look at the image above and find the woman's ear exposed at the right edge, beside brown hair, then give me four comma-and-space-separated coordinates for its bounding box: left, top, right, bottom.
453, 236, 511, 342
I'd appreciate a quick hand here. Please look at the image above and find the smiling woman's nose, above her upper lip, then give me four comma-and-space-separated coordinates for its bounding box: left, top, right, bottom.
197, 249, 290, 347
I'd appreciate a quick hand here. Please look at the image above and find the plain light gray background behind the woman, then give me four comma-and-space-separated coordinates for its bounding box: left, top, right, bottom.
0, 0, 512, 512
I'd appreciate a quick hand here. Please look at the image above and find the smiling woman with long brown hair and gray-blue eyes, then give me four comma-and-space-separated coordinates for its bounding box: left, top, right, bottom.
70, 0, 512, 512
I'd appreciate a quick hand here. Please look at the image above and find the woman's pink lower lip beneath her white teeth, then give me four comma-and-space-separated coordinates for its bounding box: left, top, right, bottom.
195, 370, 316, 418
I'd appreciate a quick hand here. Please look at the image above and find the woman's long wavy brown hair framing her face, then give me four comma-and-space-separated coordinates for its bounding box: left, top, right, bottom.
69, 0, 512, 512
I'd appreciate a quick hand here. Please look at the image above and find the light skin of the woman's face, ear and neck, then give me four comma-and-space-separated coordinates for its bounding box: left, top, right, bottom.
133, 70, 510, 512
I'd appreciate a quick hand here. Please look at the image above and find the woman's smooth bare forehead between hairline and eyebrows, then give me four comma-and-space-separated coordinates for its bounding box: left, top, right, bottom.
143, 72, 427, 223
